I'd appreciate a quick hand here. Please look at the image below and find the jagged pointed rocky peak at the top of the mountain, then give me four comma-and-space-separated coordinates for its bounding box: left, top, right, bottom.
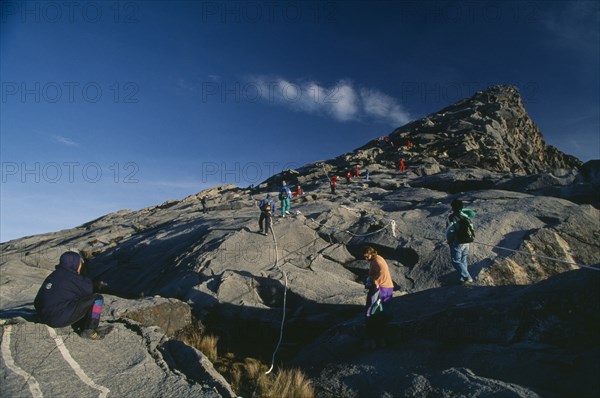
359, 86, 581, 174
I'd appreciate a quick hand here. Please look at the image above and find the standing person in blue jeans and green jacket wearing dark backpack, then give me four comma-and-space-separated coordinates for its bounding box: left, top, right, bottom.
446, 199, 476, 285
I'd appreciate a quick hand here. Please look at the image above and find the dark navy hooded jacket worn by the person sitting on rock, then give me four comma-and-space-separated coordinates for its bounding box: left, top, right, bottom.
33, 252, 94, 327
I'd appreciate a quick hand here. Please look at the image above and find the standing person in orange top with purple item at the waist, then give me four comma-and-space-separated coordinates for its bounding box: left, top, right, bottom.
363, 246, 394, 349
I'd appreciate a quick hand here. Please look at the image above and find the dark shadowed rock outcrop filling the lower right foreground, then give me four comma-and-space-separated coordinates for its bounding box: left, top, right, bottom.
292, 270, 600, 397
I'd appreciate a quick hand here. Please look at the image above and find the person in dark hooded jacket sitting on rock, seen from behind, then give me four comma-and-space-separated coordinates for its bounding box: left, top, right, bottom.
34, 251, 105, 340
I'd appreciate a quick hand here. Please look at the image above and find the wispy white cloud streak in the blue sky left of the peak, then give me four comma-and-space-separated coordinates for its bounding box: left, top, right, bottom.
251, 77, 410, 126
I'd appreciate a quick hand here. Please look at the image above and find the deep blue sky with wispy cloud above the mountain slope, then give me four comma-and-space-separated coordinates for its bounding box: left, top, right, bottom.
0, 1, 600, 242
